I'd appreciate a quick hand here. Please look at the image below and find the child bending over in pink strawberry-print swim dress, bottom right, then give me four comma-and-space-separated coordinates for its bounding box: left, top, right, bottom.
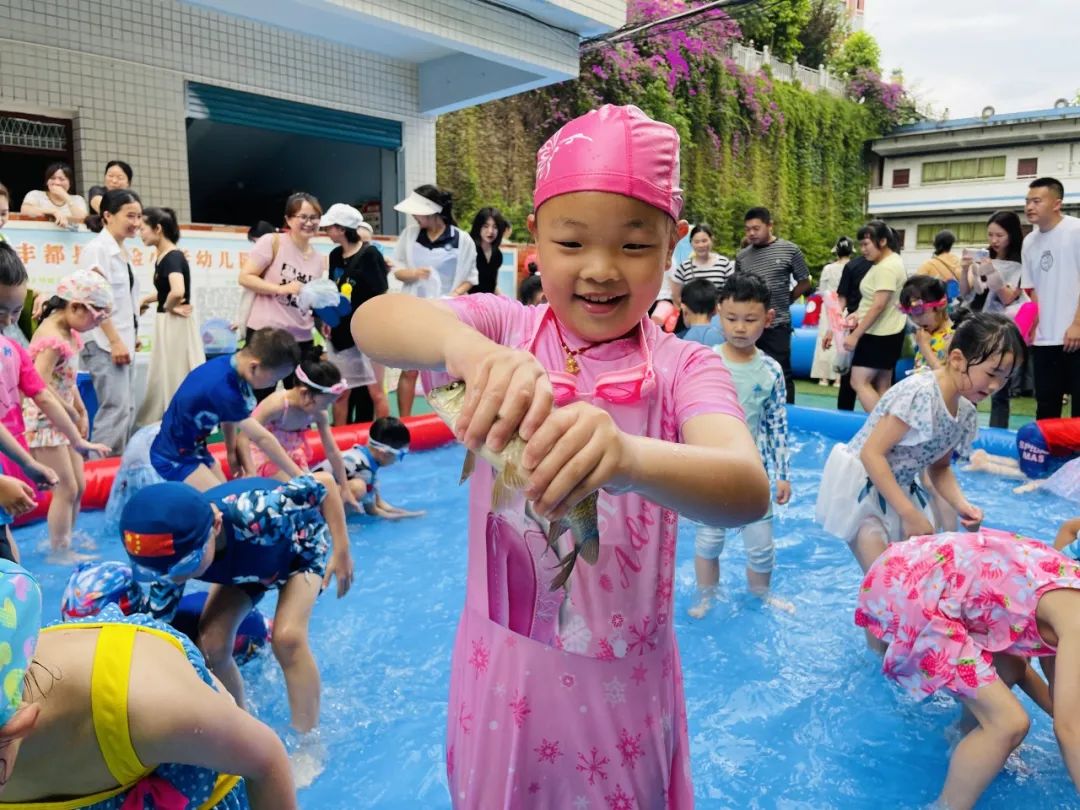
855, 529, 1080, 810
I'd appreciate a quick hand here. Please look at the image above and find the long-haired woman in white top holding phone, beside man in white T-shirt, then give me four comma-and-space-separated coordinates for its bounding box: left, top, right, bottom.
960, 211, 1031, 428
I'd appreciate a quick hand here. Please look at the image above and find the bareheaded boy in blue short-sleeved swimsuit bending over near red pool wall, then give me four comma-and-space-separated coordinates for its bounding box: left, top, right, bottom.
150, 328, 302, 491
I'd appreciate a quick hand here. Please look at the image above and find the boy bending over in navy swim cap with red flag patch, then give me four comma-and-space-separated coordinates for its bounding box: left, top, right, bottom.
120, 475, 352, 733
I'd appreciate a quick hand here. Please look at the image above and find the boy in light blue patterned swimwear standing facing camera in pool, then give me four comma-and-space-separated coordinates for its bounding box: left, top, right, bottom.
683, 271, 795, 619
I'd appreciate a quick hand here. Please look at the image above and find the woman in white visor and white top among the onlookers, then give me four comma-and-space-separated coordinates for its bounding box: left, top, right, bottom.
393, 185, 480, 417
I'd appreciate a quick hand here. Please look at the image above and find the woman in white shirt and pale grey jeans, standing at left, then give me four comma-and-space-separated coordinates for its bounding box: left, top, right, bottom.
80, 189, 143, 456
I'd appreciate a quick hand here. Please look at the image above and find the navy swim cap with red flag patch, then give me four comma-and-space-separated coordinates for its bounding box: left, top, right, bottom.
120, 482, 214, 578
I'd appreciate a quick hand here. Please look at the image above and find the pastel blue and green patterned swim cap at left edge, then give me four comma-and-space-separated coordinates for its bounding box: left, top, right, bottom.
0, 559, 41, 725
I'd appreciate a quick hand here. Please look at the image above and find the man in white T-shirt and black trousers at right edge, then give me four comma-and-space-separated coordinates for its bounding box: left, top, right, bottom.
1021, 177, 1080, 419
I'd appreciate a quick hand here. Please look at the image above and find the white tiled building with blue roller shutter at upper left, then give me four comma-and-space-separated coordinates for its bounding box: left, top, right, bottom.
0, 0, 626, 231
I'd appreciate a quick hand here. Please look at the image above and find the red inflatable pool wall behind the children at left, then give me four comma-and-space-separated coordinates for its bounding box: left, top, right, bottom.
15, 414, 454, 526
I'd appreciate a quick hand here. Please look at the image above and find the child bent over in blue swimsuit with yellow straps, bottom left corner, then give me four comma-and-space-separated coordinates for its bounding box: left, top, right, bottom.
0, 561, 296, 810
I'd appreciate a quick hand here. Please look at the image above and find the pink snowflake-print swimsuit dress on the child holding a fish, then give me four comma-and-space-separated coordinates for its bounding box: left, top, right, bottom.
424, 295, 742, 810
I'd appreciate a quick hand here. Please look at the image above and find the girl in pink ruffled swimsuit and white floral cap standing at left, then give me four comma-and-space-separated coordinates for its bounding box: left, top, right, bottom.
23, 270, 112, 564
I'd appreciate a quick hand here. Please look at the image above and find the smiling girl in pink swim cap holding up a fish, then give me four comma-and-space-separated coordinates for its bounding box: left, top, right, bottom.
353, 106, 769, 810
